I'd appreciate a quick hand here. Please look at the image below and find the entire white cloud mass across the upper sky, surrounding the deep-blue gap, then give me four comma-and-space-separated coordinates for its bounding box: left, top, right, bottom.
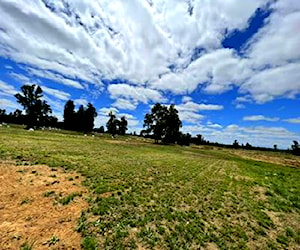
0, 0, 300, 106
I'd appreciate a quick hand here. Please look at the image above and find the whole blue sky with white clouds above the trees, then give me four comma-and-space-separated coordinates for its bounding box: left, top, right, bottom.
0, 0, 300, 149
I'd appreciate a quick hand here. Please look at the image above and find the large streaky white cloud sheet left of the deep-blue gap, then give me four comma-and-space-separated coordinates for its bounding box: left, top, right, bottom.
0, 0, 266, 92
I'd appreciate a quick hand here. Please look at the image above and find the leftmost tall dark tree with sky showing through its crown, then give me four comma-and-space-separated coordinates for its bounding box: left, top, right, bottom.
15, 84, 52, 128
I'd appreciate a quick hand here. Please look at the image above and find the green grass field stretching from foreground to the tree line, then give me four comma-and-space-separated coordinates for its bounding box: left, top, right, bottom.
0, 127, 300, 249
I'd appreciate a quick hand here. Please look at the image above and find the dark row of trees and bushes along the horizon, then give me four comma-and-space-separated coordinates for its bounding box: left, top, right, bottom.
0, 84, 300, 155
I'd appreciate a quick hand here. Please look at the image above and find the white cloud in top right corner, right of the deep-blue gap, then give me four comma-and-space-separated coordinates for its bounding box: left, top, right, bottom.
248, 0, 300, 67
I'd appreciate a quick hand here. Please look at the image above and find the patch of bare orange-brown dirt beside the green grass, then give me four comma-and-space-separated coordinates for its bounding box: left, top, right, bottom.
0, 161, 87, 250
